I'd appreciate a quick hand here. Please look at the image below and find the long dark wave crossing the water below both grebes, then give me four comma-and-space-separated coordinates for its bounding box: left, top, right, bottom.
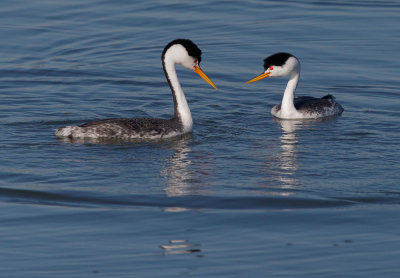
0, 188, 400, 210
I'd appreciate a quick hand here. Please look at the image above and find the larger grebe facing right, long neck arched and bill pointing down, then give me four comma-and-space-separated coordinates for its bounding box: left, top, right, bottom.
55, 39, 217, 140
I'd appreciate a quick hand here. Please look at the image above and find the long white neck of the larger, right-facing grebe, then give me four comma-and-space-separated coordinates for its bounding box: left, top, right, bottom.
163, 55, 193, 132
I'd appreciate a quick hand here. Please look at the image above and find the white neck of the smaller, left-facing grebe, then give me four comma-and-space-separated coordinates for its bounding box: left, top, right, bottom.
280, 67, 300, 119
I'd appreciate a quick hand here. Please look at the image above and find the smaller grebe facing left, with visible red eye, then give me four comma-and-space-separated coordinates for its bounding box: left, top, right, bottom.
246, 52, 344, 119
